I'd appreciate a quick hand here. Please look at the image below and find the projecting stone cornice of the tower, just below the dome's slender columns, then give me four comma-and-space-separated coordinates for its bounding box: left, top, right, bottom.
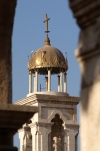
15, 94, 80, 105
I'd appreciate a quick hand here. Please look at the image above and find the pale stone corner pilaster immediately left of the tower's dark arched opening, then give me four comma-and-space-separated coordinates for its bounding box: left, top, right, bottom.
30, 123, 52, 151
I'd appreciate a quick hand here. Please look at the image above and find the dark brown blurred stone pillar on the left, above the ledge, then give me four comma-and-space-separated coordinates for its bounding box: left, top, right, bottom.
0, 0, 16, 103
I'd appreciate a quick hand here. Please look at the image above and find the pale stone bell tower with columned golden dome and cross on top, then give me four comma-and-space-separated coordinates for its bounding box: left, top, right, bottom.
15, 15, 79, 151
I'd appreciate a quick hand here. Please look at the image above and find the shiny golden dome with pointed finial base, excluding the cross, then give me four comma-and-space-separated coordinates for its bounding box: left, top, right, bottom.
28, 35, 68, 74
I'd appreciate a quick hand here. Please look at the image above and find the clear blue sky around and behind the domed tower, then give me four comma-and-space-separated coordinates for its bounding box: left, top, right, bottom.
12, 0, 80, 150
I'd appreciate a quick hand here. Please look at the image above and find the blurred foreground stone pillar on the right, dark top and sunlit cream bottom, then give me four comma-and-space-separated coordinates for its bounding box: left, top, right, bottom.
69, 0, 100, 151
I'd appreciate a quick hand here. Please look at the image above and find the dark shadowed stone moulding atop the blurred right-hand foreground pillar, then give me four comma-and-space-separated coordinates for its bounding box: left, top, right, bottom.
69, 0, 100, 29
